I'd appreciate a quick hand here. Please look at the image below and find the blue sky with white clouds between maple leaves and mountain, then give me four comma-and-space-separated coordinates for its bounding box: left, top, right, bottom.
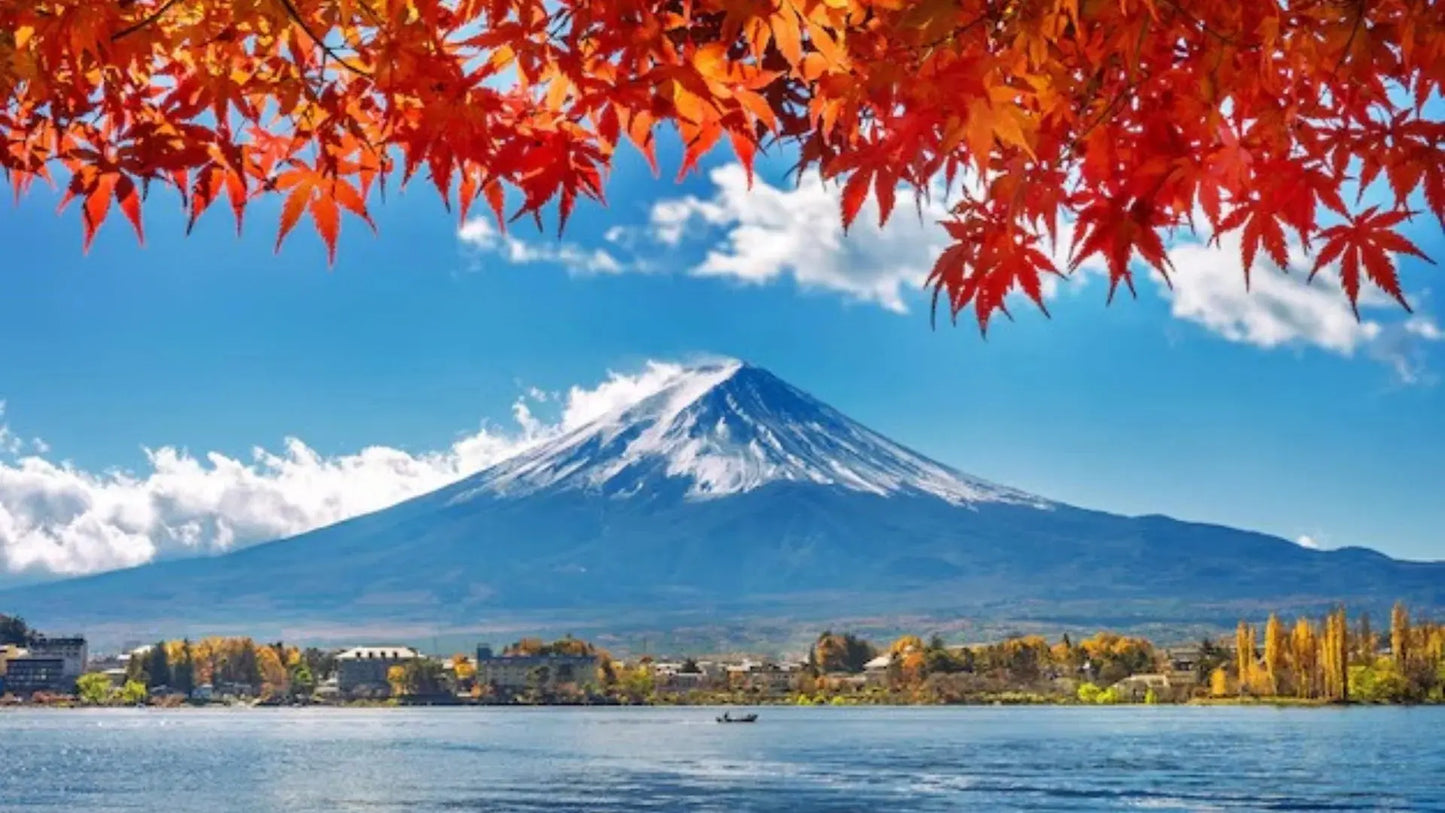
0, 133, 1445, 581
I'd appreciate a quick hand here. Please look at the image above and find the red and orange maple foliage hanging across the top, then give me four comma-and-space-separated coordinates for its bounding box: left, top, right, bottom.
0, 0, 1445, 328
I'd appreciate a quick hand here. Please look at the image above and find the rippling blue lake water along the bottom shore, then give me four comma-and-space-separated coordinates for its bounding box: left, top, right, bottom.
0, 706, 1445, 813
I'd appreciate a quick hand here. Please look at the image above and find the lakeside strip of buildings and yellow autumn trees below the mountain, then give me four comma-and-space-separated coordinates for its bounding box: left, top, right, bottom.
0, 605, 1445, 708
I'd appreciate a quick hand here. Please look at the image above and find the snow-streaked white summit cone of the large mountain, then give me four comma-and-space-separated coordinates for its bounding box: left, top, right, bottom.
452, 361, 1048, 507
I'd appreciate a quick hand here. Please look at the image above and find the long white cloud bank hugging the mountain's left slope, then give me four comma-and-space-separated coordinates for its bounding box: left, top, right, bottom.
0, 362, 681, 582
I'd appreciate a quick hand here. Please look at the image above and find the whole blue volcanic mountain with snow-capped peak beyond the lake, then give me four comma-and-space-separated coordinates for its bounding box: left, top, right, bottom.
0, 361, 1445, 644
